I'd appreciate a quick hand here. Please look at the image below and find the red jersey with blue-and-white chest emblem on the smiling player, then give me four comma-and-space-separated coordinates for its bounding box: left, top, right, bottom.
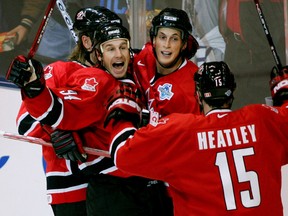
134, 43, 200, 116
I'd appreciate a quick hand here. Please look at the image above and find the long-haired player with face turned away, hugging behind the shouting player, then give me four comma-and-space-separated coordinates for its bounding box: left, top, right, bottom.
17, 6, 121, 216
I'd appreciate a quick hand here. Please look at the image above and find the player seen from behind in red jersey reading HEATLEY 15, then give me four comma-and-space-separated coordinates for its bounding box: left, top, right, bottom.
108, 62, 288, 216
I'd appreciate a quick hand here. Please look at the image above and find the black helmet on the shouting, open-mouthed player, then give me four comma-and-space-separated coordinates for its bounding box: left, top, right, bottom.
96, 24, 131, 52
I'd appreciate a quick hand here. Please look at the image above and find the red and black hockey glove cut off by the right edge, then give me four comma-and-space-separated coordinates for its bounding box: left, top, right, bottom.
269, 66, 288, 106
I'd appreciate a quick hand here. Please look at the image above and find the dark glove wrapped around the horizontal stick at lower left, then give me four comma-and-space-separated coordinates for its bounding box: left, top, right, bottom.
50, 130, 87, 162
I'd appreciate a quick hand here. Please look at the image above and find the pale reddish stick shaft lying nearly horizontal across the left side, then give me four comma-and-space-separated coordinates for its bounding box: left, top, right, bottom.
0, 130, 110, 158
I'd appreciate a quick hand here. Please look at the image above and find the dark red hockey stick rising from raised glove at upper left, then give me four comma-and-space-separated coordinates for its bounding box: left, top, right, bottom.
27, 0, 56, 59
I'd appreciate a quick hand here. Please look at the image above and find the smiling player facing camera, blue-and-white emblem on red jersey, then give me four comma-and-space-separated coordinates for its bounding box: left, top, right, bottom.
134, 8, 200, 116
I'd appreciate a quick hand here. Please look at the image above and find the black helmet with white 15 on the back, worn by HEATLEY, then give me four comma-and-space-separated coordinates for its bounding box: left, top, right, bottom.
194, 61, 236, 107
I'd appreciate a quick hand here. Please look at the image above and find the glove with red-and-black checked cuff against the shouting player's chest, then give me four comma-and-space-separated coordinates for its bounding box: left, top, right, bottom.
104, 83, 144, 128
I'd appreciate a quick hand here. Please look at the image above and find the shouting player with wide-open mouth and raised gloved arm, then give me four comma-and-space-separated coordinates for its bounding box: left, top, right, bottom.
6, 16, 171, 216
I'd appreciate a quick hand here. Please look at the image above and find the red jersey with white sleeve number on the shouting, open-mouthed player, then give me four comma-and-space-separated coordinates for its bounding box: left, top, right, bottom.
23, 67, 132, 177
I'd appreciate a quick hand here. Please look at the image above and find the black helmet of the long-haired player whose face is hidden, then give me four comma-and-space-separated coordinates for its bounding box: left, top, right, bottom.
73, 6, 122, 32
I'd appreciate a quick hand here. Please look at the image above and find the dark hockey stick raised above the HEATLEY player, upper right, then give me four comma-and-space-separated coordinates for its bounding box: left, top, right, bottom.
254, 0, 282, 71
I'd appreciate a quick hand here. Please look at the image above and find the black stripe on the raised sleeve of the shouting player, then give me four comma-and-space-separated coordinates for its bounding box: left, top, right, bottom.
40, 92, 63, 125
